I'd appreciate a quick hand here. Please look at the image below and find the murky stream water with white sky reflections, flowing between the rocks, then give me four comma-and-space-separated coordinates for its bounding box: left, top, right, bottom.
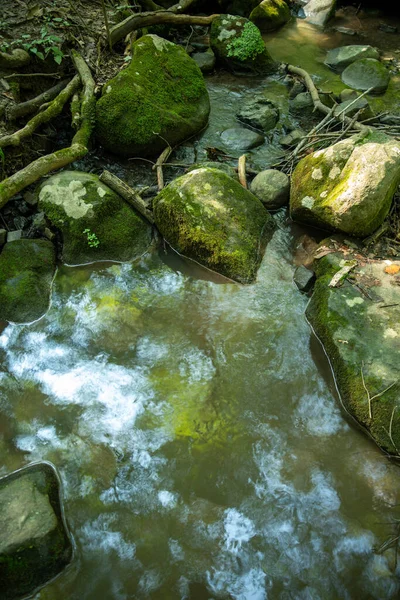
0, 11, 400, 600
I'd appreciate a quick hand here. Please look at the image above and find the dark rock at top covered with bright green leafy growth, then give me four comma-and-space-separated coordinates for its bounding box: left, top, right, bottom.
210, 15, 276, 74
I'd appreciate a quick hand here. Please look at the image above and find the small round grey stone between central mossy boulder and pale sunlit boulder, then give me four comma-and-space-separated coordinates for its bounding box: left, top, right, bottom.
250, 169, 290, 210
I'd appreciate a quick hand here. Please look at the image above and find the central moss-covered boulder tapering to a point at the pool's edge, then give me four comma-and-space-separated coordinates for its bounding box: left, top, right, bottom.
153, 169, 273, 283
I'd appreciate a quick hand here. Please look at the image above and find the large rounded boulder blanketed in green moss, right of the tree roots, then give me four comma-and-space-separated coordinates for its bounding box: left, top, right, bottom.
96, 35, 210, 156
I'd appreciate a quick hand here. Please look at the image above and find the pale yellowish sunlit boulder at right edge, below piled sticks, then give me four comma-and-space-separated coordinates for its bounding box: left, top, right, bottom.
290, 136, 400, 237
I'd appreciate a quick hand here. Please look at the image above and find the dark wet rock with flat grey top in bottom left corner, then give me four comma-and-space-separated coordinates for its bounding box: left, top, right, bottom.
0, 463, 72, 600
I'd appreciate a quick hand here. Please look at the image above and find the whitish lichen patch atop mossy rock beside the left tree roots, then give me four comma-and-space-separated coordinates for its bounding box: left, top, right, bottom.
39, 180, 93, 219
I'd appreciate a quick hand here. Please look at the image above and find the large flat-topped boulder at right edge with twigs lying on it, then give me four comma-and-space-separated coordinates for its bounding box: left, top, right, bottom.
307, 242, 400, 454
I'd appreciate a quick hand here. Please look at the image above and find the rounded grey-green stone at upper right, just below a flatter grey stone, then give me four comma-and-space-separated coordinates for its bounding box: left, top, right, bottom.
342, 58, 390, 94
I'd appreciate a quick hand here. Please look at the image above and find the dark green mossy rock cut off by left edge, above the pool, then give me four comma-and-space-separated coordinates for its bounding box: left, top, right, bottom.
0, 239, 56, 323
